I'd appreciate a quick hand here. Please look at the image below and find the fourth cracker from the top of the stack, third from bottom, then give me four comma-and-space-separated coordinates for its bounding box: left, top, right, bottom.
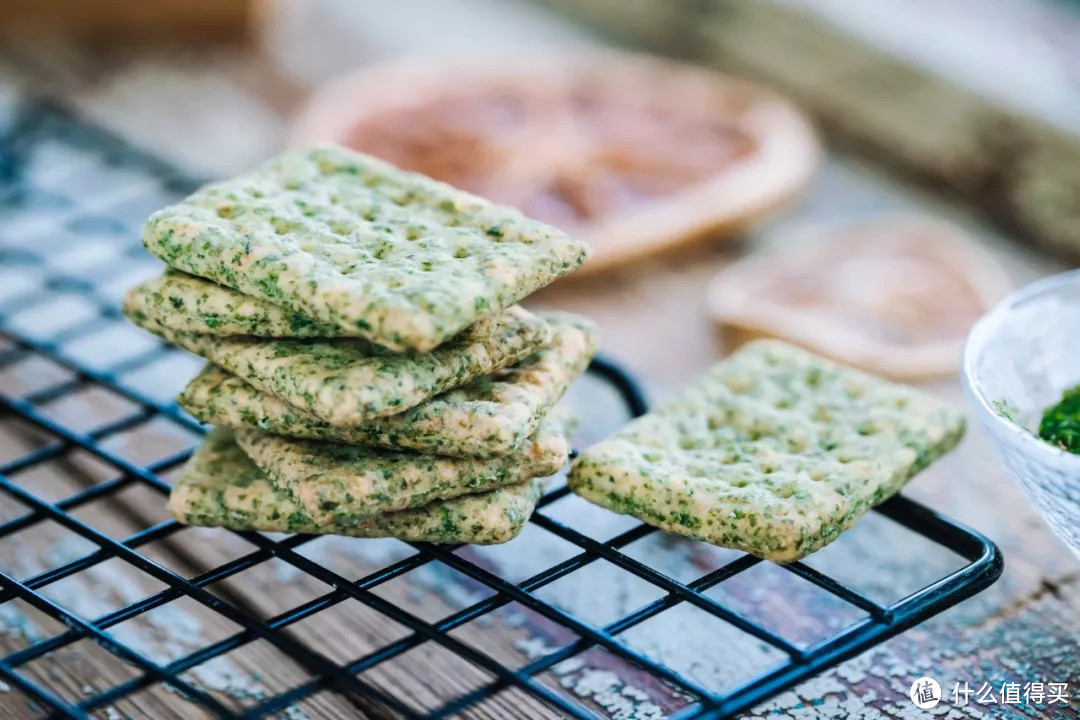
178, 313, 599, 458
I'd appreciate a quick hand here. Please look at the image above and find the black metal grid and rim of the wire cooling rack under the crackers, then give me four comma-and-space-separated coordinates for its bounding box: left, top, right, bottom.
0, 103, 1002, 720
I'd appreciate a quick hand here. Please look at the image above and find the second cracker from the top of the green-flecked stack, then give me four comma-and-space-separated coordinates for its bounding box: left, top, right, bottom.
124, 269, 341, 338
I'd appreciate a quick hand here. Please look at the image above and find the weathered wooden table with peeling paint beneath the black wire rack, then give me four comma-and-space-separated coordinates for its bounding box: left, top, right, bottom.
0, 3, 1080, 719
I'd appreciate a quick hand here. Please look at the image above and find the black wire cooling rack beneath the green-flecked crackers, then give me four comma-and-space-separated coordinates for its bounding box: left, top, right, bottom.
0, 104, 1002, 720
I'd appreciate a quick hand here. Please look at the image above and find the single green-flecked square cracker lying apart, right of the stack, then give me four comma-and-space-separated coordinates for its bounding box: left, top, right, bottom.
569, 341, 964, 562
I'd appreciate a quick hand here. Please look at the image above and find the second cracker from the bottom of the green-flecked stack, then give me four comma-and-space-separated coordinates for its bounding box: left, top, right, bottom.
235, 414, 569, 525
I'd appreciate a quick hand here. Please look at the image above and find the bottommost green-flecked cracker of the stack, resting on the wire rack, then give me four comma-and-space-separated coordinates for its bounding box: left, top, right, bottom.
168, 429, 544, 545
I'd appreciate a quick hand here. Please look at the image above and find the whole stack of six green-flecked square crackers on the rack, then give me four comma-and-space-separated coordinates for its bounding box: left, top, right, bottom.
124, 147, 598, 543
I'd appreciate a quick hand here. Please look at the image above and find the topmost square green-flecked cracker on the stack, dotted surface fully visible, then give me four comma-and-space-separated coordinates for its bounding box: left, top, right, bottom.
143, 147, 589, 352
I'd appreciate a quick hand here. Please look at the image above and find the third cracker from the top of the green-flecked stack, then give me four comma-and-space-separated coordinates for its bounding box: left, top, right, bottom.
132, 305, 551, 427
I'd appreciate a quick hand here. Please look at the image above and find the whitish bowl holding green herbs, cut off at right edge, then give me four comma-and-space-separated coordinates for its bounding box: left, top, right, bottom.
963, 270, 1080, 557
